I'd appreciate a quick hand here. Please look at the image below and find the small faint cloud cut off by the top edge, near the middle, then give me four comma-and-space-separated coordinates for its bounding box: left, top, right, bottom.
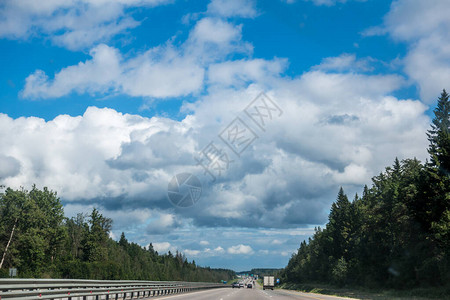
207, 0, 257, 18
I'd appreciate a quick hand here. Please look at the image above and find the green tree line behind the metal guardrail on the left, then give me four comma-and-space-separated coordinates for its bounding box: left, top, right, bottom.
0, 186, 235, 282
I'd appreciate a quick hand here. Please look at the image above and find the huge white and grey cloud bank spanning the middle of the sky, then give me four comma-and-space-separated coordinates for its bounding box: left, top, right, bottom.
0, 70, 429, 229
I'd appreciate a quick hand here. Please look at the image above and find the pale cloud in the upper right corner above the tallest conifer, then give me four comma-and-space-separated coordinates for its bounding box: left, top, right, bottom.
365, 0, 450, 103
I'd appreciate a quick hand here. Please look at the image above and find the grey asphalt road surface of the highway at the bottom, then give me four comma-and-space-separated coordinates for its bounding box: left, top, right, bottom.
156, 288, 354, 300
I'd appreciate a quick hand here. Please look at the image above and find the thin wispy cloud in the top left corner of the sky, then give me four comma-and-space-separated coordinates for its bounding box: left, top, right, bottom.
0, 0, 171, 50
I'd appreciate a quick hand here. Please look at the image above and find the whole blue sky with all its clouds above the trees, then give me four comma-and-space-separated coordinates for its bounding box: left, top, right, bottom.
0, 0, 450, 271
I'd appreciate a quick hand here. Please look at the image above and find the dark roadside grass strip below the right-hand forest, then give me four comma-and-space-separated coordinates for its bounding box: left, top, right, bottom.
280, 283, 450, 300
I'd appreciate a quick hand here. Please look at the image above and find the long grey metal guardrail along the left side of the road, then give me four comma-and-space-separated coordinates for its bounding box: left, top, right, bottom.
0, 279, 229, 300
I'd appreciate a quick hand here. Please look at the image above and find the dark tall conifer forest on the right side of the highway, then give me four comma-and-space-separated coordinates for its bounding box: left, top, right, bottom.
282, 90, 450, 289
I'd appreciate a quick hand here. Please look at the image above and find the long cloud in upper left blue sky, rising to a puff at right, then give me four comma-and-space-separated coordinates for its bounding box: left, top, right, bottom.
21, 18, 251, 99
